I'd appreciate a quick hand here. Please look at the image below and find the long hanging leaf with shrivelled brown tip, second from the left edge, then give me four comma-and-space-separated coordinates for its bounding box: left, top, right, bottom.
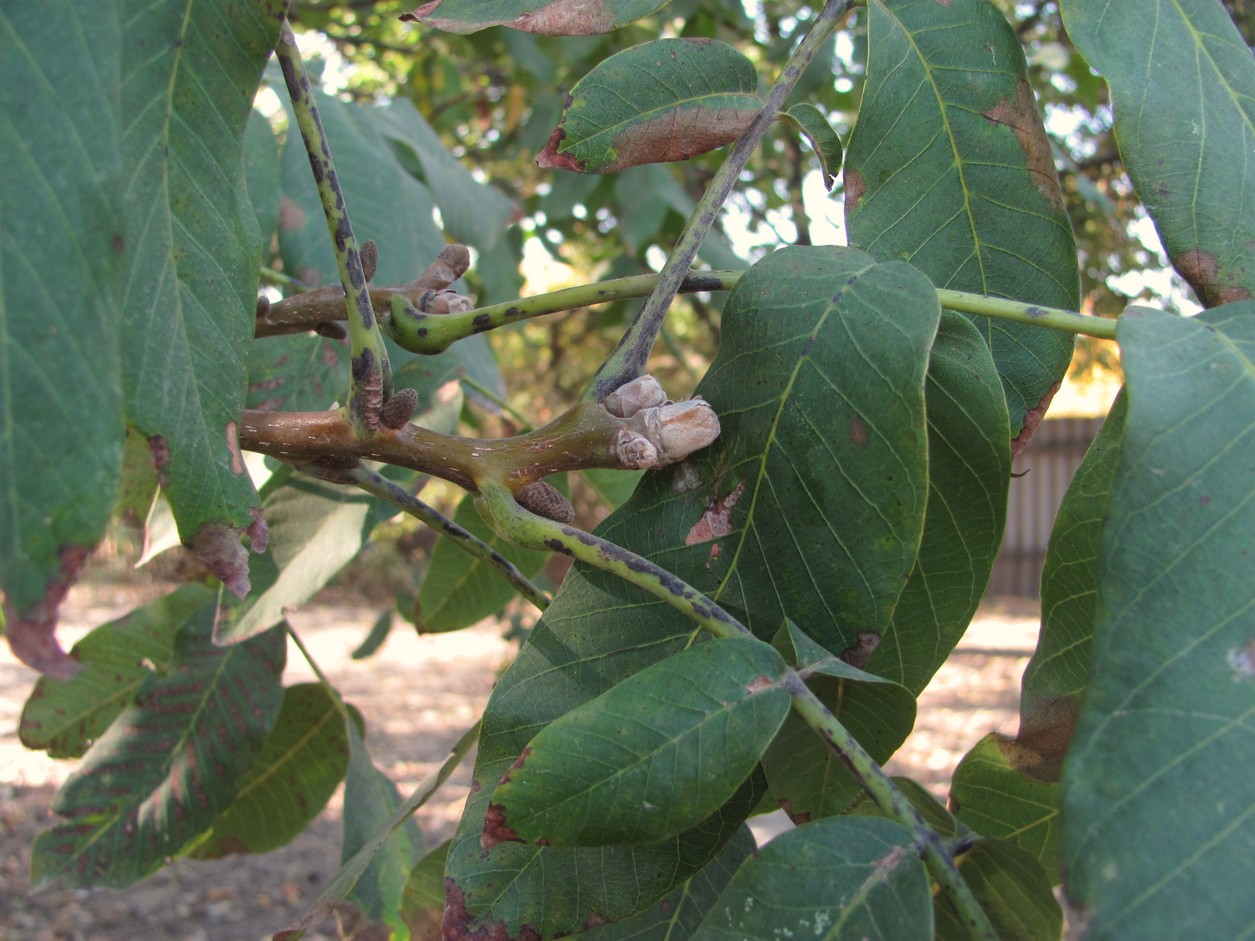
122, 0, 286, 597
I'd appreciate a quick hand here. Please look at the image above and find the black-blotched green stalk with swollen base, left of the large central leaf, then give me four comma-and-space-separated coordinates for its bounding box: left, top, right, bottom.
383, 271, 742, 354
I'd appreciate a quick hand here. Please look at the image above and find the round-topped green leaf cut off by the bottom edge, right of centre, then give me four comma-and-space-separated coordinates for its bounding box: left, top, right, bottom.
693, 817, 932, 941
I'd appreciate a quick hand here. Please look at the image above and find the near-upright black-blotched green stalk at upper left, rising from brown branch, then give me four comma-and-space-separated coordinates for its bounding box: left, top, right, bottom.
275, 21, 392, 437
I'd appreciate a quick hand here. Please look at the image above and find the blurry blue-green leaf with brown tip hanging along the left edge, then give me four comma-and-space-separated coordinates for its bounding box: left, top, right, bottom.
0, 3, 126, 675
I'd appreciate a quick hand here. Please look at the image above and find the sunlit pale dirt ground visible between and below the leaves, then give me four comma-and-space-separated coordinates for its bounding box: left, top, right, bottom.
0, 588, 1038, 941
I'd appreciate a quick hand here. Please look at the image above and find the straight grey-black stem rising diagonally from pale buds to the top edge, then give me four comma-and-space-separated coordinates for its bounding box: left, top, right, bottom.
582, 0, 850, 401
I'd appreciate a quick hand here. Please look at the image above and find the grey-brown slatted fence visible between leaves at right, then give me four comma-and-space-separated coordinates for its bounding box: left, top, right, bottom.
986, 418, 1103, 597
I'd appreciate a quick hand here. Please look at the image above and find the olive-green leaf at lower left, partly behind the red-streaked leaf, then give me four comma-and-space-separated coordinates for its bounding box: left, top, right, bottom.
195, 683, 349, 859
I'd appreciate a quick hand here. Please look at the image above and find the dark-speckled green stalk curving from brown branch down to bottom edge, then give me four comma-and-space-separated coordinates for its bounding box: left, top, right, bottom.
477, 484, 998, 941
